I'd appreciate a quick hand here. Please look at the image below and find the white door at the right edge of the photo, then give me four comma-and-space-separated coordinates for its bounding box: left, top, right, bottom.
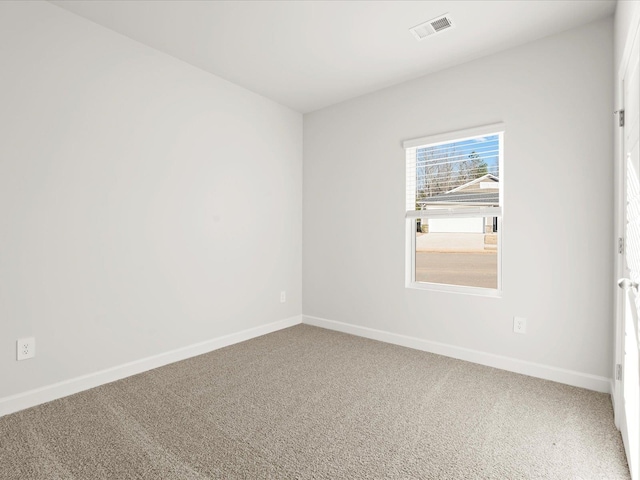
616, 23, 640, 480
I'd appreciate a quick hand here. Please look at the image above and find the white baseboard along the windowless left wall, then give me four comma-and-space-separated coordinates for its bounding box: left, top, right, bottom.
0, 315, 302, 417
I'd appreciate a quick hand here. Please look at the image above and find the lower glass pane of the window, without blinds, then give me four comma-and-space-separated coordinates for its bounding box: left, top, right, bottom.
414, 217, 499, 289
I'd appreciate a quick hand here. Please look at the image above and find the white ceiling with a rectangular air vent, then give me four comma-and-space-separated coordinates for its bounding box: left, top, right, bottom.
51, 0, 616, 113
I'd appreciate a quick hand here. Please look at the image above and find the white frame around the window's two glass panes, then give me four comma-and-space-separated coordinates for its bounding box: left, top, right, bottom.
402, 123, 505, 297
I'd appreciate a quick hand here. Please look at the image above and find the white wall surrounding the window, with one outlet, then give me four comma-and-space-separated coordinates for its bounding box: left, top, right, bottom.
303, 19, 613, 383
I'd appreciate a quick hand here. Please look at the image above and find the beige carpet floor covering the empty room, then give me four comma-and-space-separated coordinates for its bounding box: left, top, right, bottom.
0, 325, 629, 480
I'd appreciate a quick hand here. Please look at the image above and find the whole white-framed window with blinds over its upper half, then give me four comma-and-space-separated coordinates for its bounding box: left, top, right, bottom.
404, 124, 504, 296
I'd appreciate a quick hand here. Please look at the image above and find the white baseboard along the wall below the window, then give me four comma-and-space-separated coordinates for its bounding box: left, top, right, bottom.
302, 315, 612, 393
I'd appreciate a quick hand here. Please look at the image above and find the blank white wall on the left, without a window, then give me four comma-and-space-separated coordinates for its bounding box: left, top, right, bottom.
0, 2, 302, 398
